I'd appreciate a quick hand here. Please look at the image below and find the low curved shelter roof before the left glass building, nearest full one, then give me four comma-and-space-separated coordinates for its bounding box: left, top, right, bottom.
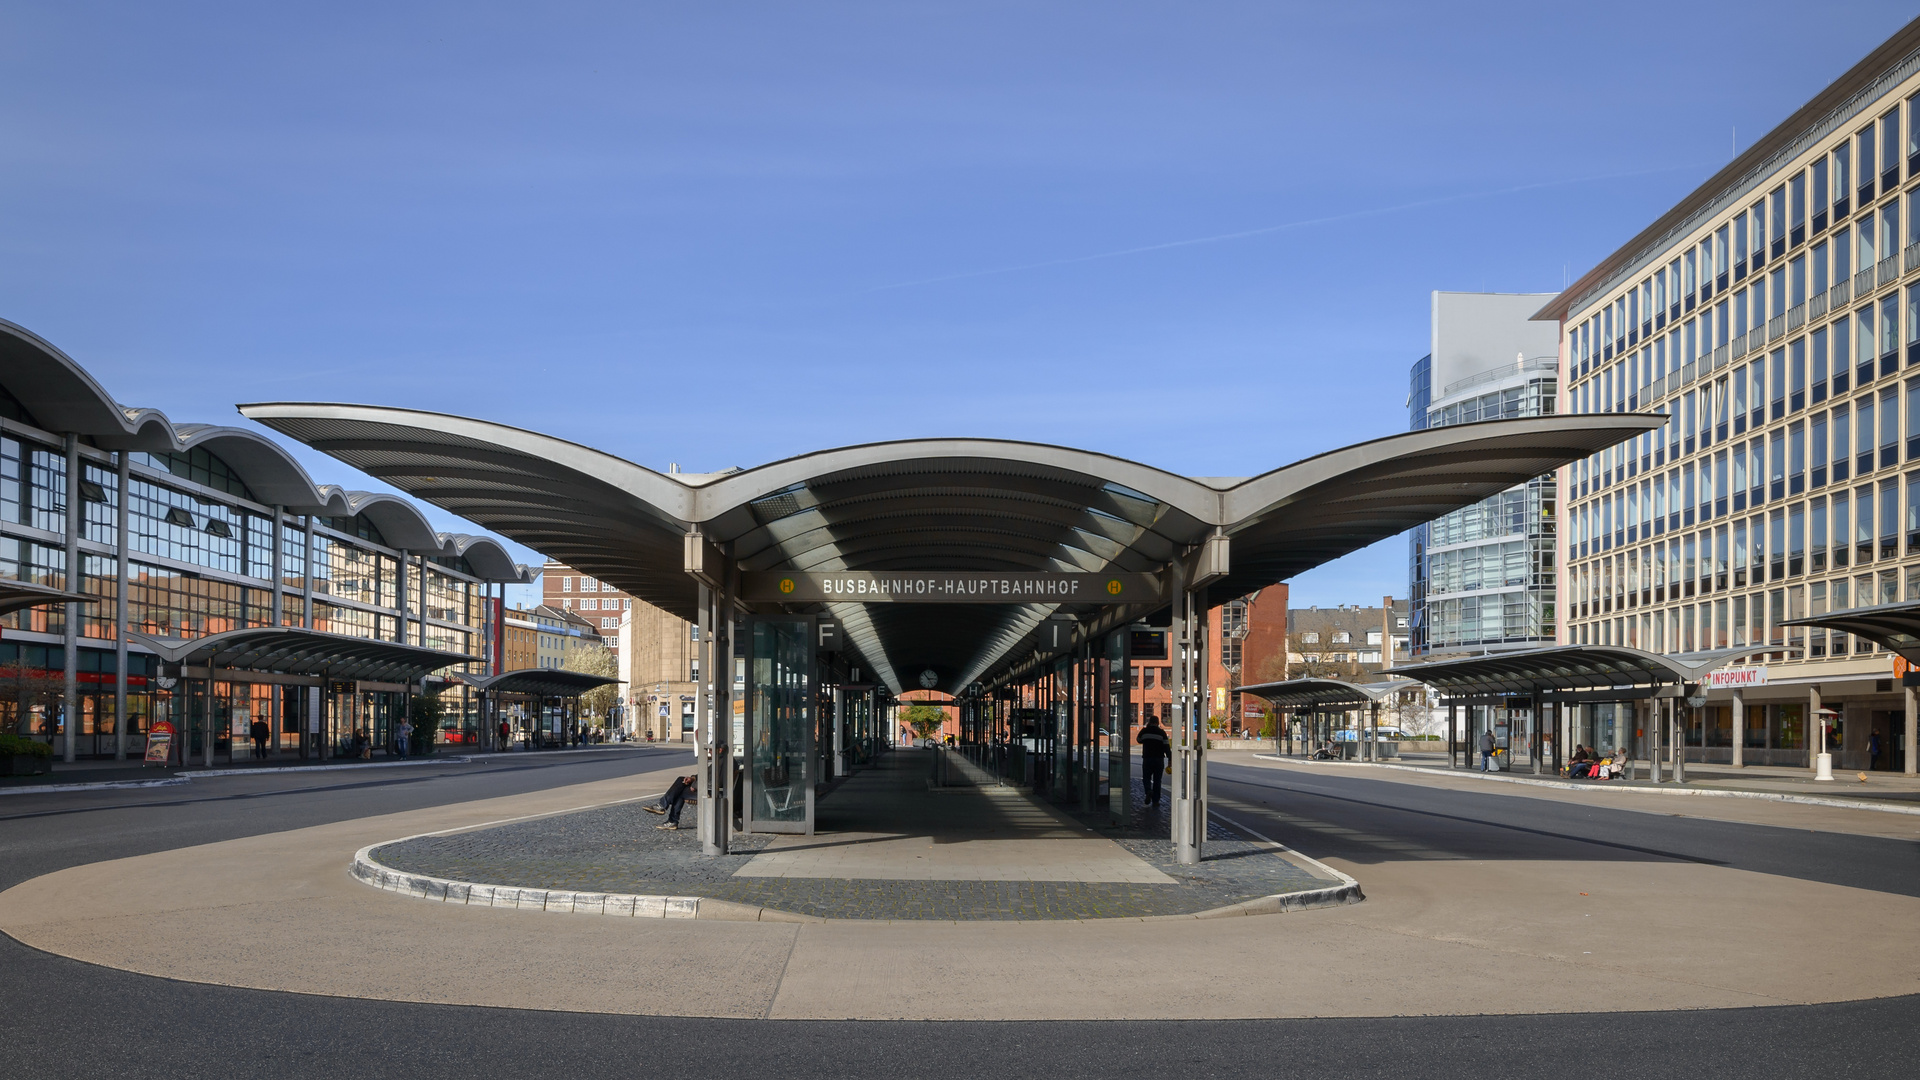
132, 626, 480, 682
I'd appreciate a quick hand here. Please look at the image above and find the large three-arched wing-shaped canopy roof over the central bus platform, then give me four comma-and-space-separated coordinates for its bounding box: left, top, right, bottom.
240, 404, 1665, 690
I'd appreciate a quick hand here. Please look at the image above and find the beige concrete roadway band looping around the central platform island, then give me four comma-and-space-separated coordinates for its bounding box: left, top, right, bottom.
0, 755, 1920, 1024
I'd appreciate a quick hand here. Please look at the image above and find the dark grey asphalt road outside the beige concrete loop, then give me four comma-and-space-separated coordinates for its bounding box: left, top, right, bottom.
0, 748, 1920, 1080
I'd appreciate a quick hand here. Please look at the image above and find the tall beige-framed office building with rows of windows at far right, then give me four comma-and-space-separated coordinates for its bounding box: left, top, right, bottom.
1538, 21, 1920, 771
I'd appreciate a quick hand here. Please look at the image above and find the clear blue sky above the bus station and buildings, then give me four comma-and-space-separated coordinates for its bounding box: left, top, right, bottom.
0, 0, 1912, 605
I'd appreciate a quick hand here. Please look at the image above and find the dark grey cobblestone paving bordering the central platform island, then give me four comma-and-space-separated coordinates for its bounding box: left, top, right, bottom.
374, 760, 1327, 920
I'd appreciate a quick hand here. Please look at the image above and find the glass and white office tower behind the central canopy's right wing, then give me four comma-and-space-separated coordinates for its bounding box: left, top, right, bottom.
1402, 292, 1559, 659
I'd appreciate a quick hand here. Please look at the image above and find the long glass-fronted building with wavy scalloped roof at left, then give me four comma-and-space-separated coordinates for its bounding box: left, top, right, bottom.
0, 321, 528, 757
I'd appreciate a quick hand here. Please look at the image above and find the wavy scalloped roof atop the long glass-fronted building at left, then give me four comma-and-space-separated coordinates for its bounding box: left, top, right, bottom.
0, 319, 532, 580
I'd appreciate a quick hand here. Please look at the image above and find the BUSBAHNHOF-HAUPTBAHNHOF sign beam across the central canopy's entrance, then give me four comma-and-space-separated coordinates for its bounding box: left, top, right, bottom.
739, 571, 1160, 603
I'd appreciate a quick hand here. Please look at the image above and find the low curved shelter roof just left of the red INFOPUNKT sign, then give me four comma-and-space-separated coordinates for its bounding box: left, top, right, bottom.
1394, 646, 1782, 698
